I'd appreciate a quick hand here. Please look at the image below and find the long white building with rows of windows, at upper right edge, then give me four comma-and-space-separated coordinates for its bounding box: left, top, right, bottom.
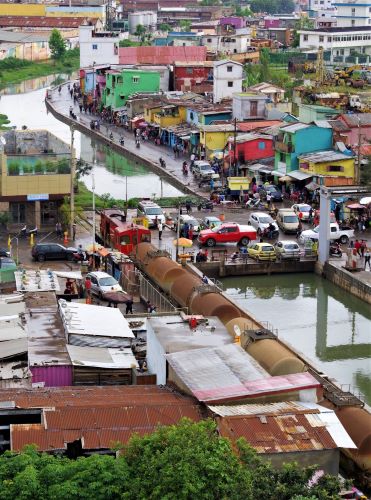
299, 25, 371, 64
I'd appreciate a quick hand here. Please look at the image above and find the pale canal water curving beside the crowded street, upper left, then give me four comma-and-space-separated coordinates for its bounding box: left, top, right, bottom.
0, 83, 182, 199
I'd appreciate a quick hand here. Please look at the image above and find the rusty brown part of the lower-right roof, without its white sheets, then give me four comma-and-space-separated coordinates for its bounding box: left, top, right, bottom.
218, 413, 337, 453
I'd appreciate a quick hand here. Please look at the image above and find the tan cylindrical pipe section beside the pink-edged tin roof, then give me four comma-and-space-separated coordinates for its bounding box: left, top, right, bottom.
246, 339, 305, 376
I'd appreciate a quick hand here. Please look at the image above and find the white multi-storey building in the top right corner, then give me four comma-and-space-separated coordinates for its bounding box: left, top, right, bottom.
334, 0, 371, 28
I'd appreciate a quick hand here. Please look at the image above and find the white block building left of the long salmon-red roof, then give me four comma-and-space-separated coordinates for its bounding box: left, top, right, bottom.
79, 26, 128, 68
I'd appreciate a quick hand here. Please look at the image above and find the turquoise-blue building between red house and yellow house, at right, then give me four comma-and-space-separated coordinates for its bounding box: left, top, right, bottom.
274, 122, 332, 175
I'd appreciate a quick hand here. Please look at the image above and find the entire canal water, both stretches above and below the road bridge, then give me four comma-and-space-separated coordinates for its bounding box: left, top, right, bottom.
0, 79, 371, 405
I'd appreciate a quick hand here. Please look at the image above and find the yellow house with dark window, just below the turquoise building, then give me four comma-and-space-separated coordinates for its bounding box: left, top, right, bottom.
298, 151, 355, 185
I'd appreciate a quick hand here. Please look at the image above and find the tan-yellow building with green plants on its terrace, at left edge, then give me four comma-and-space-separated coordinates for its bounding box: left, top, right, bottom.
0, 130, 71, 228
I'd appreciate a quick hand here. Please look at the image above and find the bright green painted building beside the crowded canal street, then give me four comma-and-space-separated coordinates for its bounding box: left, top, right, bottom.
102, 69, 160, 109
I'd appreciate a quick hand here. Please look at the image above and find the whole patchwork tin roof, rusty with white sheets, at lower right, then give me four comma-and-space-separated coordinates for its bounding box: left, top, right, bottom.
215, 402, 356, 453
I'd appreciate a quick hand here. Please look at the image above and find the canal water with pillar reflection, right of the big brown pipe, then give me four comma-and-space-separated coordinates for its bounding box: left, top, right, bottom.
222, 273, 371, 405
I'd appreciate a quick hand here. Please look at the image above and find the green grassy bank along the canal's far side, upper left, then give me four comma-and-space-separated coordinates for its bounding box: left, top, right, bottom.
0, 49, 80, 87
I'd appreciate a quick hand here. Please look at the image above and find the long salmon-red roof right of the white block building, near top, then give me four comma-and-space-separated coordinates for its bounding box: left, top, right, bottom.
119, 47, 207, 64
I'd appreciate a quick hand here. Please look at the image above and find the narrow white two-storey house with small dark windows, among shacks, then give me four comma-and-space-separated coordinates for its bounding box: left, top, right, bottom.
213, 60, 243, 103
